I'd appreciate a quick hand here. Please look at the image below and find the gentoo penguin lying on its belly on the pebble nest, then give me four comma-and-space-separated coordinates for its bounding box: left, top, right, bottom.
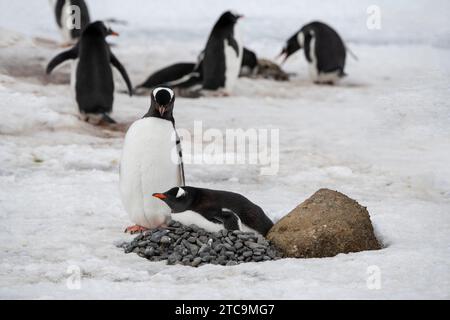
153, 186, 273, 236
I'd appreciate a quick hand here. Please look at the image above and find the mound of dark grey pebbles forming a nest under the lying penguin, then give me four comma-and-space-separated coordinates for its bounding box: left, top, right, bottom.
122, 221, 281, 267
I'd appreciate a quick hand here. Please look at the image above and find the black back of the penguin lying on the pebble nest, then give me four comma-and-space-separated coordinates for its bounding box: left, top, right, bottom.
183, 187, 273, 236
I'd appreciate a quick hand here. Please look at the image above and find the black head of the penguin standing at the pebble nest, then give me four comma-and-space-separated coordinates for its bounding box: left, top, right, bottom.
144, 87, 175, 121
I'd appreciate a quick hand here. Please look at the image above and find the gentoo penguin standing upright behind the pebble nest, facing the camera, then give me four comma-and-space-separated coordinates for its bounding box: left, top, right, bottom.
120, 87, 184, 233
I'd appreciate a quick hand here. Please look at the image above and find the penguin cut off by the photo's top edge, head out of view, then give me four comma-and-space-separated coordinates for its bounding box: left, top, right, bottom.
50, 0, 90, 44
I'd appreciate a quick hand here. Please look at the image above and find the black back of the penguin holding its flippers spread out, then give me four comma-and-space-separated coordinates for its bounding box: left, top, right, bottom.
75, 27, 114, 113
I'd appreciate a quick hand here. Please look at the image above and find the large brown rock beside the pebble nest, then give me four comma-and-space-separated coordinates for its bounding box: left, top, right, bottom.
267, 189, 381, 258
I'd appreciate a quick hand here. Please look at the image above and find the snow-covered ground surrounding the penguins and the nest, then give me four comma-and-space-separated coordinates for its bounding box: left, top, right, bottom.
0, 0, 450, 299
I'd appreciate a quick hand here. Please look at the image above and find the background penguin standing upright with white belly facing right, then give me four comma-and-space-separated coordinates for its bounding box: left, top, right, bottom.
202, 11, 243, 94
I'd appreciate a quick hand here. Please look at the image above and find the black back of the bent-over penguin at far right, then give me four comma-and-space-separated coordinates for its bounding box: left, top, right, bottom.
301, 21, 346, 73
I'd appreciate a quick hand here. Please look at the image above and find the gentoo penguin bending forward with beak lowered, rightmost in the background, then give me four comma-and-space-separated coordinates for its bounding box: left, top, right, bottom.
280, 21, 346, 84
